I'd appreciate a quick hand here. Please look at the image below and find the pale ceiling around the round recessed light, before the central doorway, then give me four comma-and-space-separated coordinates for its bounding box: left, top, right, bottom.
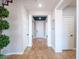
23, 0, 60, 11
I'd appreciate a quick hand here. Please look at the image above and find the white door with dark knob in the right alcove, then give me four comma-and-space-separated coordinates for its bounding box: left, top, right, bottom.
63, 16, 75, 49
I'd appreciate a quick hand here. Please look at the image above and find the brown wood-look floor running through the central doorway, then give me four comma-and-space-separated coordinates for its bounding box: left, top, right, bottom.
7, 38, 76, 59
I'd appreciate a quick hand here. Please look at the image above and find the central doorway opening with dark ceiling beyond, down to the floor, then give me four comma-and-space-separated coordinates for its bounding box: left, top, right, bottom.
32, 16, 47, 38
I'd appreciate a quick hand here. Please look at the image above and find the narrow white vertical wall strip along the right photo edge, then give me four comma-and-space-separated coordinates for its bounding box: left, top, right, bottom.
76, 0, 79, 59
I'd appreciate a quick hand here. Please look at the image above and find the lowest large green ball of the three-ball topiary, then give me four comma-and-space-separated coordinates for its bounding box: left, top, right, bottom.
0, 35, 10, 48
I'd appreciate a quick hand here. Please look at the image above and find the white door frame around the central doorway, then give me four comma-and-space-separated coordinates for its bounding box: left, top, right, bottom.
28, 14, 52, 47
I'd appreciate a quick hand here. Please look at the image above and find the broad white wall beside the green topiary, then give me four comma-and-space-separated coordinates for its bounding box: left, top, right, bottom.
2, 0, 28, 55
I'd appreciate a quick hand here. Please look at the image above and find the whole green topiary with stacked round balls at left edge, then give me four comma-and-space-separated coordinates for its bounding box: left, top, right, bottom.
0, 6, 10, 59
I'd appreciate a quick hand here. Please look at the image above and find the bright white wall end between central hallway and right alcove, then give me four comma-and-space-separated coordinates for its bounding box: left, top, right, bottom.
55, 9, 63, 52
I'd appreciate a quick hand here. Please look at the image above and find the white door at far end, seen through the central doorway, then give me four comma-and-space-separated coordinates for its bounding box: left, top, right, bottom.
36, 21, 45, 37
